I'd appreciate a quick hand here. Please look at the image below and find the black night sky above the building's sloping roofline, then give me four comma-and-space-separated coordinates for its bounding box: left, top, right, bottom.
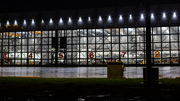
0, 0, 180, 13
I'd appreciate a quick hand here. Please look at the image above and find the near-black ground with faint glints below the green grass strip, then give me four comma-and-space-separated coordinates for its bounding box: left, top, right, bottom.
0, 77, 180, 101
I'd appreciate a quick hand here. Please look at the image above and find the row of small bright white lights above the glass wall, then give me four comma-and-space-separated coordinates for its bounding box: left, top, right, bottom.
7, 12, 177, 25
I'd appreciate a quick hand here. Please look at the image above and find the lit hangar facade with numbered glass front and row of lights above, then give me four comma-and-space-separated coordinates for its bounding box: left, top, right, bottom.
0, 4, 180, 66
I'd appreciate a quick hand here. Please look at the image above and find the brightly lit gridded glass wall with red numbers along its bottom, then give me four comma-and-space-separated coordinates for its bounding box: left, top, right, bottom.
0, 26, 180, 65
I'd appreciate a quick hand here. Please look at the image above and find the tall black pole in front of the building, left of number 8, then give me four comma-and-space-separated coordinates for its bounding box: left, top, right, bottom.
146, 0, 152, 86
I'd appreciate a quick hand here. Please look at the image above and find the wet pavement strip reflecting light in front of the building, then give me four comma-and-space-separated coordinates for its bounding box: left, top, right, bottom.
0, 66, 180, 78
